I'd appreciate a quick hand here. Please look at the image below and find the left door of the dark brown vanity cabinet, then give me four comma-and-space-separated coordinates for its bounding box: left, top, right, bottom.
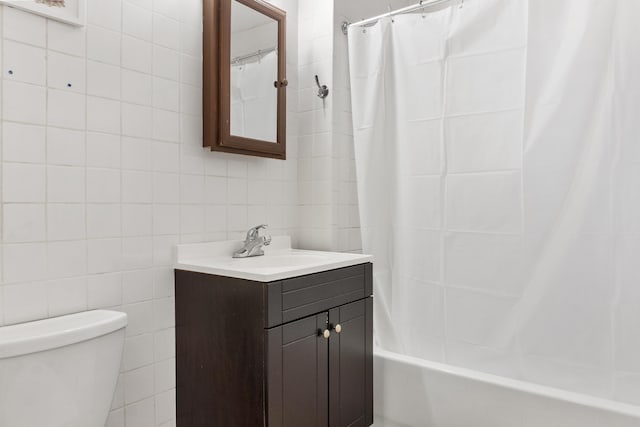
267, 312, 329, 427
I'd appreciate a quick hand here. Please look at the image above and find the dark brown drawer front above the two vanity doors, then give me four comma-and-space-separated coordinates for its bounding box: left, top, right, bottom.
281, 264, 371, 323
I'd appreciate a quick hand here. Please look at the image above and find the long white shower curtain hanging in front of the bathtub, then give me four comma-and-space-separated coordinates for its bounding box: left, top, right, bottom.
349, 0, 640, 404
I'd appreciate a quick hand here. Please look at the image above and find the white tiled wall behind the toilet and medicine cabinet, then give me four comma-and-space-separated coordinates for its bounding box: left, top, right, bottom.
0, 0, 299, 427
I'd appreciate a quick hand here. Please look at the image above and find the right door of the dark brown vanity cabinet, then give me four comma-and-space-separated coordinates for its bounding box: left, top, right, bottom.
329, 298, 373, 427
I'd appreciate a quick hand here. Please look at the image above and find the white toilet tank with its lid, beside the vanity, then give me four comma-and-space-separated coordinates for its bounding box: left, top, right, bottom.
0, 310, 127, 427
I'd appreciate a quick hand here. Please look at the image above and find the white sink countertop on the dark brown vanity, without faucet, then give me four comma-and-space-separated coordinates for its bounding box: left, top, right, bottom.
174, 236, 373, 282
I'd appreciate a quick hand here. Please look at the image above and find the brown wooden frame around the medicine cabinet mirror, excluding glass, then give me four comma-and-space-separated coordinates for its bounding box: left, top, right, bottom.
202, 0, 288, 160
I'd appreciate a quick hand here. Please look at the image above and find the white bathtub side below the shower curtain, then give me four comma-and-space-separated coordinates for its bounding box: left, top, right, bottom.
374, 350, 640, 427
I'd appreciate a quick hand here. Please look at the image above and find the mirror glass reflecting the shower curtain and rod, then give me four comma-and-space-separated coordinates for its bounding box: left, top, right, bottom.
229, 0, 278, 143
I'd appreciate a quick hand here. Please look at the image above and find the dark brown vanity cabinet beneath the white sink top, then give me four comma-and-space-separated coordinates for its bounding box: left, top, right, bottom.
176, 263, 373, 427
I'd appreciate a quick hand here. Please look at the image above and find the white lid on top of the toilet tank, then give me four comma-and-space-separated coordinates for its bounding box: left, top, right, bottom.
0, 310, 127, 359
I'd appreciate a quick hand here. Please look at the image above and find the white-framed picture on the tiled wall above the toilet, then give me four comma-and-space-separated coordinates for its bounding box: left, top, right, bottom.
0, 0, 85, 27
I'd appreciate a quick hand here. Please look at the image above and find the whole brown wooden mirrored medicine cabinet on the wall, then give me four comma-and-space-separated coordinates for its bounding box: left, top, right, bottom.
203, 0, 288, 159
